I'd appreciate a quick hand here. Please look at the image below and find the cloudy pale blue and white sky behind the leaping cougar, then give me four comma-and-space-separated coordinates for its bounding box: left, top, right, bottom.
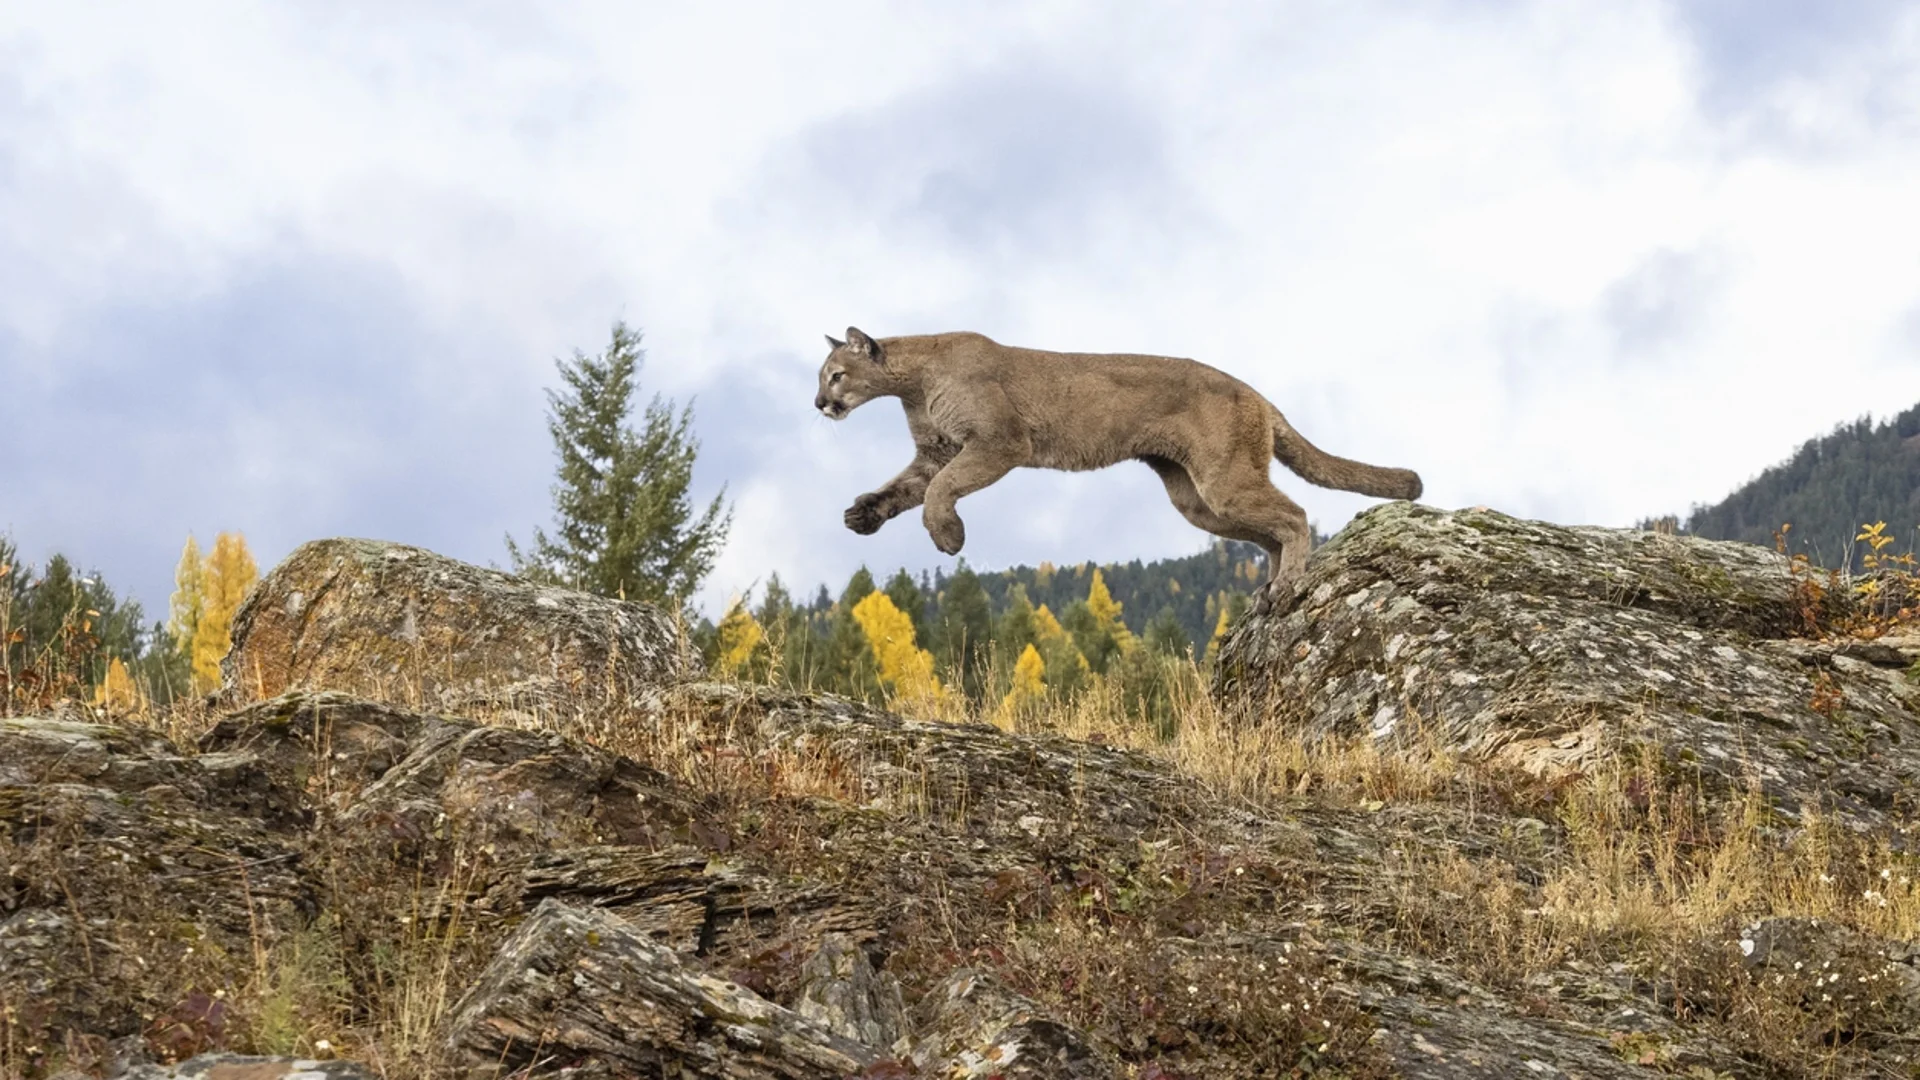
0, 0, 1920, 615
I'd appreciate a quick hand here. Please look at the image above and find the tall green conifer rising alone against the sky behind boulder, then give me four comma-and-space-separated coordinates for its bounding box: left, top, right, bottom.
507, 321, 733, 607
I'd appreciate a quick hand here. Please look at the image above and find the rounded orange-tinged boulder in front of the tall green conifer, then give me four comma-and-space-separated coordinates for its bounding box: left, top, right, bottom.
223, 540, 699, 721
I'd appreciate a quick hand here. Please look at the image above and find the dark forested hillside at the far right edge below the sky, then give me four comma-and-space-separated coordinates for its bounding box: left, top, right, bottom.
1684, 405, 1920, 567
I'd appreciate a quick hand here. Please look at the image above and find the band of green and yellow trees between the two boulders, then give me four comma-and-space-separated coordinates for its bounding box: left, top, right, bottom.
695, 542, 1265, 726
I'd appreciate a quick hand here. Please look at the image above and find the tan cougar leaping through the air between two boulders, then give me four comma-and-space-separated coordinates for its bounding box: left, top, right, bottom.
814, 327, 1421, 599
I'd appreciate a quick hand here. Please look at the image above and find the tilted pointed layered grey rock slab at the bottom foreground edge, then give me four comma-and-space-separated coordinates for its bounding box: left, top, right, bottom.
451, 899, 879, 1080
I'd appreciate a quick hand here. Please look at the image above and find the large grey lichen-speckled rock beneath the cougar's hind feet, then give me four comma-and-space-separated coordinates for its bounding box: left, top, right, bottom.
1213, 503, 1920, 828
